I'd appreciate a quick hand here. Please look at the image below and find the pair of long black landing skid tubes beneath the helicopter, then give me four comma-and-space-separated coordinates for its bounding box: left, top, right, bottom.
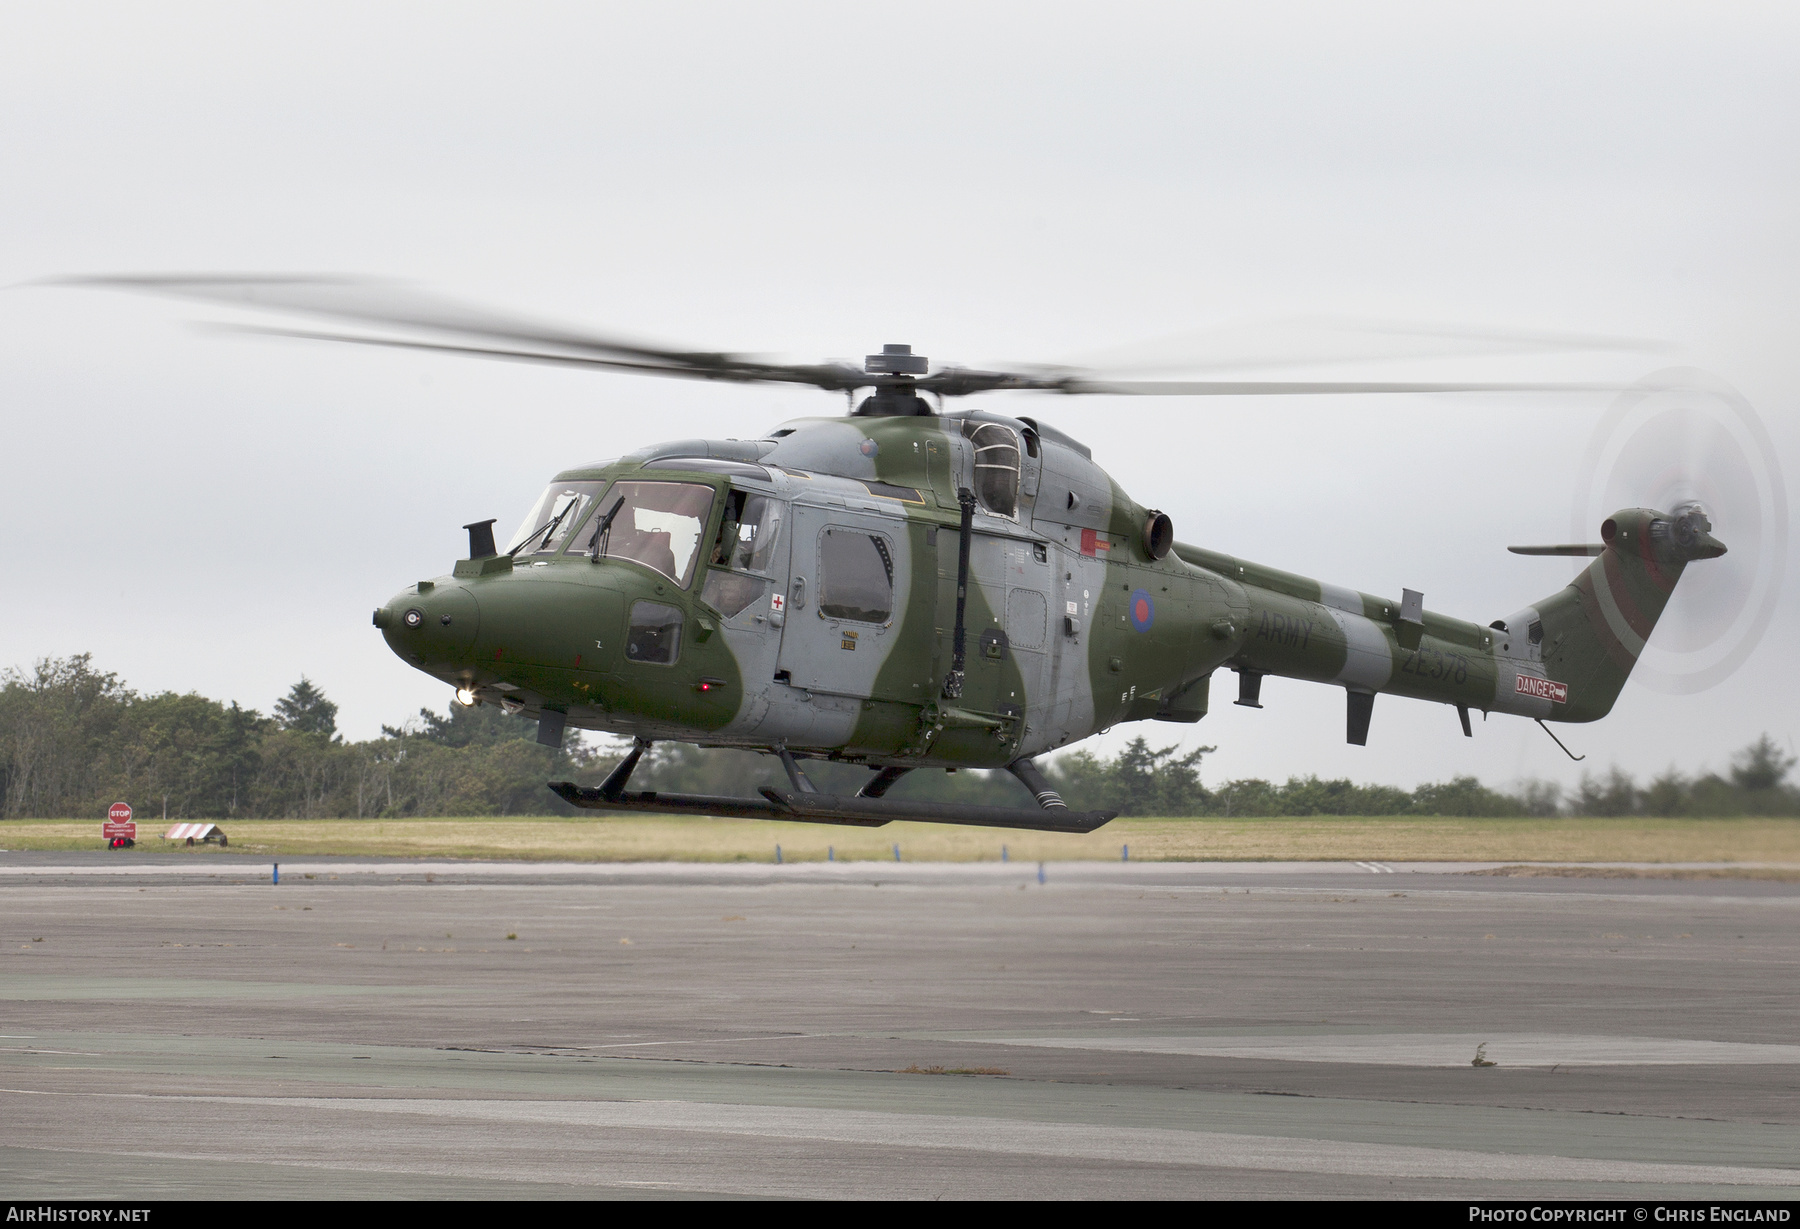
549, 781, 1118, 833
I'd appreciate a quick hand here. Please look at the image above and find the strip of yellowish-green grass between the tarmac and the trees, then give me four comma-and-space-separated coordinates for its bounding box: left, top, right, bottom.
0, 815, 1800, 866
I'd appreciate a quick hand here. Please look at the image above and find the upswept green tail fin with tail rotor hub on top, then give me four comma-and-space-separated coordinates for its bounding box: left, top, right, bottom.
1508, 506, 1724, 722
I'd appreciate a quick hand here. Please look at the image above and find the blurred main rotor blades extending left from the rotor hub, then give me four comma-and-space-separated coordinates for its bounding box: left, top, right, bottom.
50, 274, 877, 390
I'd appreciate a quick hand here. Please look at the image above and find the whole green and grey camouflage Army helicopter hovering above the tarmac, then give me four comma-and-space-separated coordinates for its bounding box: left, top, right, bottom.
66, 275, 1724, 831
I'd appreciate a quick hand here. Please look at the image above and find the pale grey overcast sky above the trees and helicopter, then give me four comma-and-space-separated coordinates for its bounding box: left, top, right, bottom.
0, 2, 1800, 785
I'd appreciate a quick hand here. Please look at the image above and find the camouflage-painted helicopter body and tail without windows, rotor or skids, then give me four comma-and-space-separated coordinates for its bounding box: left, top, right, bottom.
376, 414, 1723, 767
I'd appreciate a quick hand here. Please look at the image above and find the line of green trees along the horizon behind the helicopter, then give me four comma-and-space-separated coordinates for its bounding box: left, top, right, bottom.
0, 653, 1800, 821
